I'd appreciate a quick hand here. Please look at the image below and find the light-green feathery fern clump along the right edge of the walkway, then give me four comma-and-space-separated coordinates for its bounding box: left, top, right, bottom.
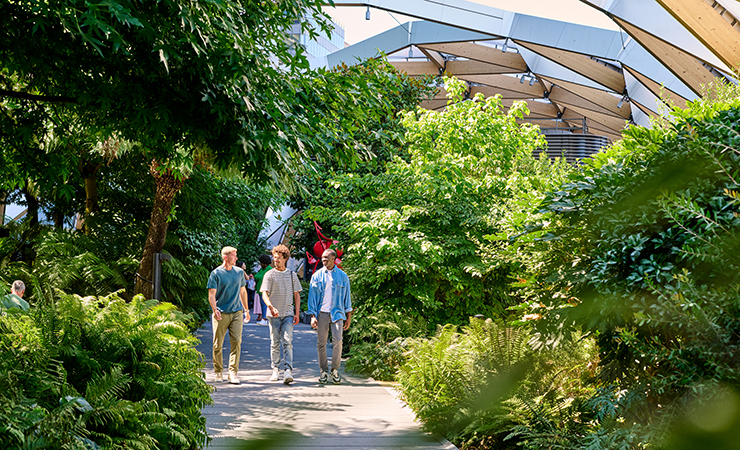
399, 319, 596, 449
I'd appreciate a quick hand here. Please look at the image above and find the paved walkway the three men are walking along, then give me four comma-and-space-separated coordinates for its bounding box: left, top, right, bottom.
197, 321, 456, 450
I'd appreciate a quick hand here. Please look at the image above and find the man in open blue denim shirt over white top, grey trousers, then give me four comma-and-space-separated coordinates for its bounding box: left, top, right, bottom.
308, 249, 352, 384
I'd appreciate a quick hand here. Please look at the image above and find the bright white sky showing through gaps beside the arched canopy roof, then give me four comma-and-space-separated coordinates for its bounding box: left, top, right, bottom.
324, 0, 617, 45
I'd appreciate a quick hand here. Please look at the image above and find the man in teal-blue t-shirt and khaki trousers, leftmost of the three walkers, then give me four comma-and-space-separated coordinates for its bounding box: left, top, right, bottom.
206, 247, 249, 384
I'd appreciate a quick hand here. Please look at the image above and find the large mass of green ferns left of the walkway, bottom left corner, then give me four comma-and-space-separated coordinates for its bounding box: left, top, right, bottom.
0, 294, 211, 450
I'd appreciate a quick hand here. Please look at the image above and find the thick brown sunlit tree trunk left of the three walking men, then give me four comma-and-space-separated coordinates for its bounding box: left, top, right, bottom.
134, 160, 184, 298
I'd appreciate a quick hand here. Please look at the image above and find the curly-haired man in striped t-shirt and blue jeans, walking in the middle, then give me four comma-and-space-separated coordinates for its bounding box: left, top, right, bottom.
260, 244, 303, 384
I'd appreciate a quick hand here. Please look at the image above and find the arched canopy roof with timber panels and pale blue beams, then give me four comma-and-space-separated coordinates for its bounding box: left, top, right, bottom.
312, 0, 740, 140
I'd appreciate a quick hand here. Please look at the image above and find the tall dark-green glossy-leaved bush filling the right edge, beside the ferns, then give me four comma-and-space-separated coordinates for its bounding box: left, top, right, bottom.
516, 81, 740, 448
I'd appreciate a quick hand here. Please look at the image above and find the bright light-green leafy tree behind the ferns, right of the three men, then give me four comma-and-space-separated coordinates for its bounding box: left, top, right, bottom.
306, 79, 568, 330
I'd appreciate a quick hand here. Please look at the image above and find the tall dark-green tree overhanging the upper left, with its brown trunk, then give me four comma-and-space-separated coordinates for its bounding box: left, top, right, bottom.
0, 0, 388, 294
